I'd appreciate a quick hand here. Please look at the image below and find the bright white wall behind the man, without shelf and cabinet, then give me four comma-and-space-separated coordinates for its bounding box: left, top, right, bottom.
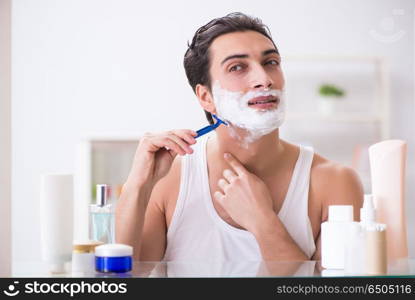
12, 0, 415, 261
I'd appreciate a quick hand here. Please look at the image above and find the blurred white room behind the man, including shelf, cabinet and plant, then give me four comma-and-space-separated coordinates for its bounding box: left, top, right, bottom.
0, 0, 415, 268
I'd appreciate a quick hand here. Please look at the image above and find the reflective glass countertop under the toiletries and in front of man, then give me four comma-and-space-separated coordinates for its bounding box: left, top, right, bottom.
12, 259, 415, 278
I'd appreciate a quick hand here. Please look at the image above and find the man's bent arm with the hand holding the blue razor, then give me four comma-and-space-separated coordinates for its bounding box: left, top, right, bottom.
115, 130, 196, 259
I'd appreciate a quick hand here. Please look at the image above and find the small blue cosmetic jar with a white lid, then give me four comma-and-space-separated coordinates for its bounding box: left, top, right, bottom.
95, 244, 133, 273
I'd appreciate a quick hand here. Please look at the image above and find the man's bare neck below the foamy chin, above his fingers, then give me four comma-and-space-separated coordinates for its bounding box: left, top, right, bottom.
211, 127, 284, 177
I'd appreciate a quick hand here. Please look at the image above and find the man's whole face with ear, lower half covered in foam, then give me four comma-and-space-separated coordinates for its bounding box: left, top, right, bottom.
196, 31, 285, 144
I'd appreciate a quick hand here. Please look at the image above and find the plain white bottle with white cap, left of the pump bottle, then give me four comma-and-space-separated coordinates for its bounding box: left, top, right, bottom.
321, 205, 353, 269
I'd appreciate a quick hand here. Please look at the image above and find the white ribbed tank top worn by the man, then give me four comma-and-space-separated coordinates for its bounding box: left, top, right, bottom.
163, 134, 316, 262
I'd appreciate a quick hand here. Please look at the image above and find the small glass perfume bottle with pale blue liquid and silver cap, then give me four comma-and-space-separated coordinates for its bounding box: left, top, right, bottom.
90, 184, 115, 244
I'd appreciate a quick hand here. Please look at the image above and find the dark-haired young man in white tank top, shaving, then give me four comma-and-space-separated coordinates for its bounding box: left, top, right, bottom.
116, 13, 363, 261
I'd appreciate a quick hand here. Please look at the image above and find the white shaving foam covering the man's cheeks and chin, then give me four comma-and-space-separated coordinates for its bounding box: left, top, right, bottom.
212, 81, 285, 146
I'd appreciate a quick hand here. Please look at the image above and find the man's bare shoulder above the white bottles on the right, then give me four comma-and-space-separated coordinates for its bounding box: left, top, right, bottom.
310, 153, 363, 219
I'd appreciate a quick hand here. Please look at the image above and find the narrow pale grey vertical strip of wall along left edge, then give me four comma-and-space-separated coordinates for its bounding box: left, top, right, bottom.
0, 0, 11, 277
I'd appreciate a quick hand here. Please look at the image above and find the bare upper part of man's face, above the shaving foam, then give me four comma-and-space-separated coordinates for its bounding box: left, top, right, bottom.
209, 31, 284, 93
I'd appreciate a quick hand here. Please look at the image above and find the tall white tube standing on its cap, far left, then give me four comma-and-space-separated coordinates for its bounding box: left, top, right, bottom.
40, 174, 73, 273
